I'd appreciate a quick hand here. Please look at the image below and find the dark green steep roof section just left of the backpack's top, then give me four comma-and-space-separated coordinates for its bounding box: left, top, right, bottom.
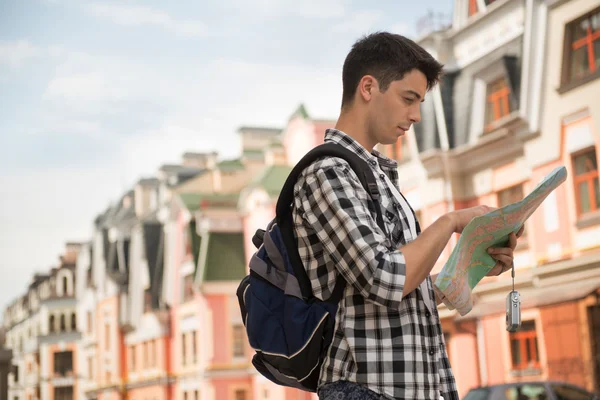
197, 232, 246, 282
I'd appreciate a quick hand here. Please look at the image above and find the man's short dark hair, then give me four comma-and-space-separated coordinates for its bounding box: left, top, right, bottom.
342, 32, 443, 108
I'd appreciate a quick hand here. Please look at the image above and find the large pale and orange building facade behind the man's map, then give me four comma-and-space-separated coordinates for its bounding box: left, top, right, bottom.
383, 0, 600, 396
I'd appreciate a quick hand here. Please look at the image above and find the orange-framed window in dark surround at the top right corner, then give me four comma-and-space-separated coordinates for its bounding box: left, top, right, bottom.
562, 9, 600, 83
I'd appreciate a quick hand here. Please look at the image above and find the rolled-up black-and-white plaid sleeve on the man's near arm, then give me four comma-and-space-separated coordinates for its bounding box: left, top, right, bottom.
301, 161, 406, 308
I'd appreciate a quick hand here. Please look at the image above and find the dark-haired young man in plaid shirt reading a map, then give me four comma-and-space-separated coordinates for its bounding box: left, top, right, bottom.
293, 33, 520, 400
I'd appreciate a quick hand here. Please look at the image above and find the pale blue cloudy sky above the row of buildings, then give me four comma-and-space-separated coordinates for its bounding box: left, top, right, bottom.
0, 0, 452, 309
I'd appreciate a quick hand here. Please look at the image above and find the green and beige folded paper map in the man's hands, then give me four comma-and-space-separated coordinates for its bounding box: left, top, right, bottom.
434, 167, 567, 315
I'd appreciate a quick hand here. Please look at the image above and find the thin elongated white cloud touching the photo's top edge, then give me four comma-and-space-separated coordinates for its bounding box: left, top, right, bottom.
86, 3, 208, 37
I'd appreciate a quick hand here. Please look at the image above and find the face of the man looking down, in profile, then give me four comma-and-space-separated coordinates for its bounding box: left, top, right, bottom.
369, 69, 427, 144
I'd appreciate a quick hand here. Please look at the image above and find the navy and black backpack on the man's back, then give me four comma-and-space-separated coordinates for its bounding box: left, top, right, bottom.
236, 143, 386, 392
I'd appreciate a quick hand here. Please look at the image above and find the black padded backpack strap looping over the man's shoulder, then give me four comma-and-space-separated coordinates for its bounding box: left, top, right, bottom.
275, 143, 387, 304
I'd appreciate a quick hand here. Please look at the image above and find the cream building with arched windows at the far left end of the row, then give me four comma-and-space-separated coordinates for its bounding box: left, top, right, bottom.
3, 243, 81, 400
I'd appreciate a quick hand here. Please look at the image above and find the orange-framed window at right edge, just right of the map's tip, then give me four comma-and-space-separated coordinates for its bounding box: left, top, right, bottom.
572, 148, 600, 214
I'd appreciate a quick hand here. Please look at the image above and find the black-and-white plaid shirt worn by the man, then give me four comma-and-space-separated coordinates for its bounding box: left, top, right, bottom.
293, 129, 458, 400
